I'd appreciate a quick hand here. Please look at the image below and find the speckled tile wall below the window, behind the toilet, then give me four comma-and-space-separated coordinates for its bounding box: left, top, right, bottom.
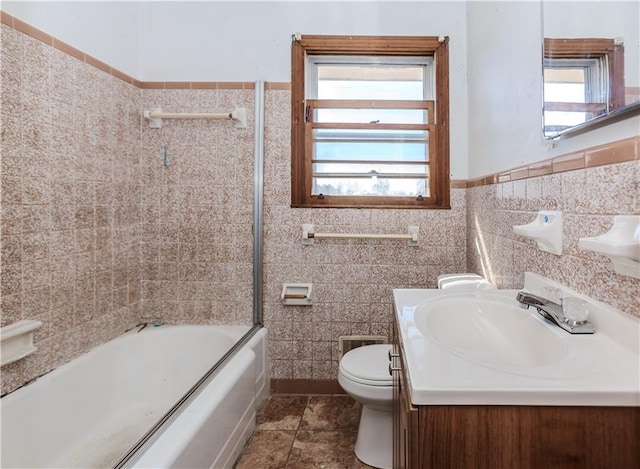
264, 89, 466, 380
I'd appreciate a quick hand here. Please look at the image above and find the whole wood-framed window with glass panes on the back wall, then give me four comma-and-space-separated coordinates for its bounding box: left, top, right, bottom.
291, 36, 449, 208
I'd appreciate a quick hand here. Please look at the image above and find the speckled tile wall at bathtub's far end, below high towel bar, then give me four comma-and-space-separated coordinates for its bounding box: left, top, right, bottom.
141, 84, 254, 326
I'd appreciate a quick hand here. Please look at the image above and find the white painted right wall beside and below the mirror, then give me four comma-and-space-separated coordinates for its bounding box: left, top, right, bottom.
467, 1, 640, 178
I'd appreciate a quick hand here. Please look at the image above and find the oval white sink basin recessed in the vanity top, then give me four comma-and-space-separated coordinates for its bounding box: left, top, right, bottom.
415, 294, 569, 368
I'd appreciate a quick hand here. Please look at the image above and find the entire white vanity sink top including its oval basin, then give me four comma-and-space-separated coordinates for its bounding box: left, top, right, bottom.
393, 273, 640, 406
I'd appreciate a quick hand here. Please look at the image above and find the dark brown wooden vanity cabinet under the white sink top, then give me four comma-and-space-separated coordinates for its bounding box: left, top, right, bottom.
391, 314, 640, 469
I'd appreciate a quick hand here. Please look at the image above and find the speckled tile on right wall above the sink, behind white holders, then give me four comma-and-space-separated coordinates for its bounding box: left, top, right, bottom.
466, 145, 640, 317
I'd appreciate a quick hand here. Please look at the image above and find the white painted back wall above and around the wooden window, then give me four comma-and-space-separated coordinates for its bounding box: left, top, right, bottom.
140, 1, 467, 179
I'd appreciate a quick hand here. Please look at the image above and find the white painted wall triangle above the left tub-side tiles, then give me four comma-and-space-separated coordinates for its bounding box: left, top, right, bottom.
0, 0, 140, 78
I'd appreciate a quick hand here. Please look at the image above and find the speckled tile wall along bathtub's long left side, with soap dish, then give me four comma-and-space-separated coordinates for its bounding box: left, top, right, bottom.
0, 24, 141, 394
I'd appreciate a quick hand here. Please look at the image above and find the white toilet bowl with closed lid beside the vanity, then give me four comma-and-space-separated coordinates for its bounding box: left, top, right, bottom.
338, 344, 393, 469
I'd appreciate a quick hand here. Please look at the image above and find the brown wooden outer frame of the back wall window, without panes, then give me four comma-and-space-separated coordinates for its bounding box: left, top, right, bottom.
291, 35, 451, 209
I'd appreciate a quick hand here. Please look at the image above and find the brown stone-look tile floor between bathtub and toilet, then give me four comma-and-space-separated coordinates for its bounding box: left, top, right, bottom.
235, 394, 371, 469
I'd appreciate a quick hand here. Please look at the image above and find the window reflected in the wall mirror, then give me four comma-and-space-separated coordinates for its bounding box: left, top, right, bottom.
543, 39, 624, 137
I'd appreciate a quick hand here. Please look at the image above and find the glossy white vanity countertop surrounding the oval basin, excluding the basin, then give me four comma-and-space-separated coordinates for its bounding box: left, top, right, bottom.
393, 274, 640, 406
